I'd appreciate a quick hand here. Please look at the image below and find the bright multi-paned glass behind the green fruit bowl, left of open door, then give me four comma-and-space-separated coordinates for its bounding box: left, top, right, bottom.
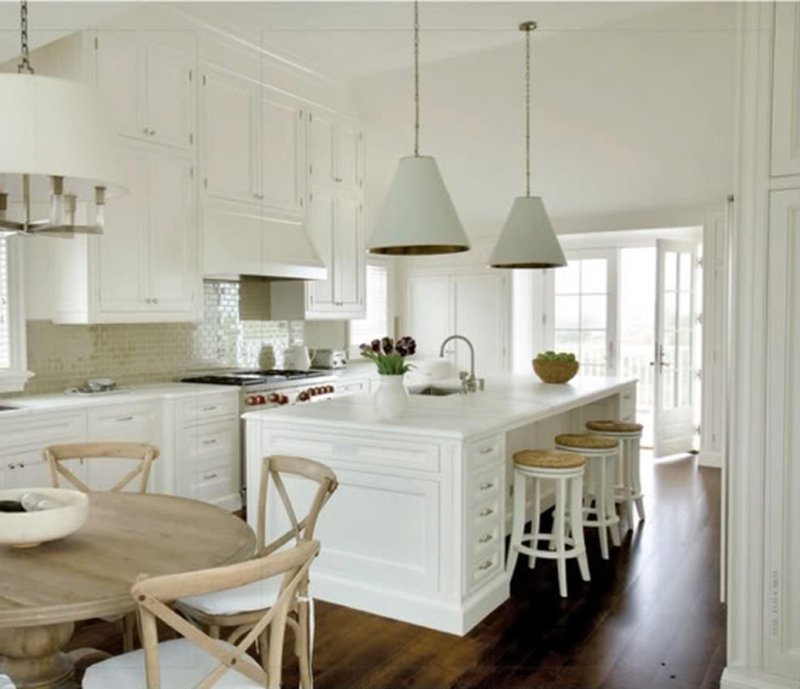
554, 252, 615, 376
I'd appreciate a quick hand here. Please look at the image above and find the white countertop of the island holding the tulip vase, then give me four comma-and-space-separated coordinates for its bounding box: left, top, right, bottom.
244, 375, 636, 438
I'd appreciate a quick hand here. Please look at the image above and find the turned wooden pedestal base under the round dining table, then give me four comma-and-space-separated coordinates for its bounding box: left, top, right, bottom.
0, 622, 76, 689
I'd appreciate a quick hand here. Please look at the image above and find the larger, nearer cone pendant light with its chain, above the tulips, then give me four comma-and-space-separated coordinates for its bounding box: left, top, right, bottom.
368, 0, 469, 256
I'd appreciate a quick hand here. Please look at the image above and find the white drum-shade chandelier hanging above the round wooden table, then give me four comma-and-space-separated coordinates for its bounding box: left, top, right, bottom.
0, 74, 126, 233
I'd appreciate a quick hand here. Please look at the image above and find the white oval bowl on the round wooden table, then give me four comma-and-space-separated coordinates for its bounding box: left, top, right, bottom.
0, 488, 89, 548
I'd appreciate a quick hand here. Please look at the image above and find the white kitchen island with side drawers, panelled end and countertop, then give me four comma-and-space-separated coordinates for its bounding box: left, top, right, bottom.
244, 376, 636, 634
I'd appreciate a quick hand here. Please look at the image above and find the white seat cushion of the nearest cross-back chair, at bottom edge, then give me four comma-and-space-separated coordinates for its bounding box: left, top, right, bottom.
81, 639, 263, 689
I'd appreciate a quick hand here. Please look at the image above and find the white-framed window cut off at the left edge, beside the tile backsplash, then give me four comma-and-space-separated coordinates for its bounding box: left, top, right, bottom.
0, 237, 30, 392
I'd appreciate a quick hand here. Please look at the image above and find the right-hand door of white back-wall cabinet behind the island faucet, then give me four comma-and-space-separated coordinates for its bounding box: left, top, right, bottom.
452, 274, 508, 377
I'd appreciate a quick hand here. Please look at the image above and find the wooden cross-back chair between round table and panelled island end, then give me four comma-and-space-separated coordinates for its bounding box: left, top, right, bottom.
178, 455, 338, 689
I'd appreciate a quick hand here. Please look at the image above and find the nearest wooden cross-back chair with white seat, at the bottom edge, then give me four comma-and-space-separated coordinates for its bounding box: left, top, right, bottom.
82, 540, 319, 689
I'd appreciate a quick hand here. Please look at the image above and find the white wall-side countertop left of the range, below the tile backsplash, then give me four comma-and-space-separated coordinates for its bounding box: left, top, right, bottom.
0, 383, 238, 419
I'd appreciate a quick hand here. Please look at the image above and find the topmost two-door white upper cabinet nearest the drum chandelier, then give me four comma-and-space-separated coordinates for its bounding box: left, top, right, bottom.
95, 31, 194, 150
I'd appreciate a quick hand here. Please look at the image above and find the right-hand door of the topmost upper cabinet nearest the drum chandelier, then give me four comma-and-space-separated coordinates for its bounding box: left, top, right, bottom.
145, 46, 192, 149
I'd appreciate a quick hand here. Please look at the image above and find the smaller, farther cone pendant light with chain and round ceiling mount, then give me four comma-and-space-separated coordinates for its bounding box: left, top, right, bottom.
489, 22, 567, 268
